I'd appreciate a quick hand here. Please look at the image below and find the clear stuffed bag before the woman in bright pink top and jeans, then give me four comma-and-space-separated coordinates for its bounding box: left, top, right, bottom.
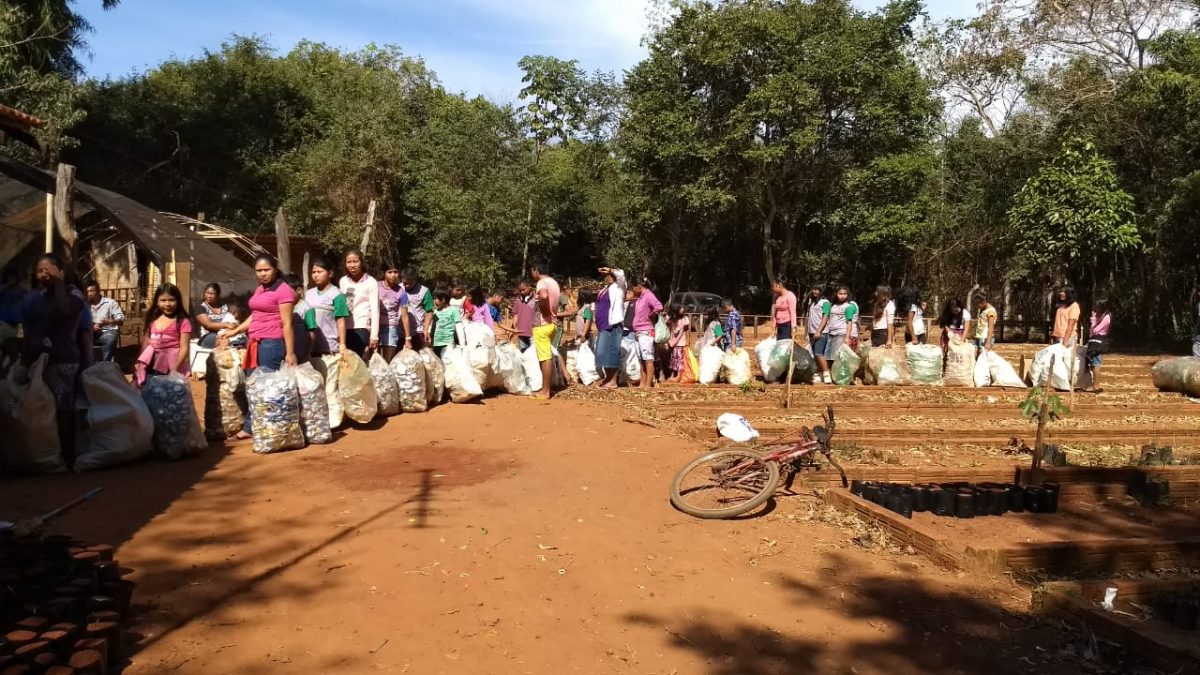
246, 364, 304, 454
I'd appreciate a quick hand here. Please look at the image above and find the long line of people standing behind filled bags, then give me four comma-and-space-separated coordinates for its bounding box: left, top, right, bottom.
7, 243, 1200, 466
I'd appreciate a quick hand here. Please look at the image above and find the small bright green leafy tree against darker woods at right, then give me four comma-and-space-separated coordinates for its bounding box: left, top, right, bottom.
1009, 137, 1141, 282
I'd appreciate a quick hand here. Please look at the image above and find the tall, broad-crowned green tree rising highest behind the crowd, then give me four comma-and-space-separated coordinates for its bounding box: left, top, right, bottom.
622, 0, 940, 281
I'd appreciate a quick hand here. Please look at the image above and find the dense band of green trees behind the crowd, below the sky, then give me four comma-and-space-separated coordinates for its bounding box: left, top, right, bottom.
0, 0, 1200, 336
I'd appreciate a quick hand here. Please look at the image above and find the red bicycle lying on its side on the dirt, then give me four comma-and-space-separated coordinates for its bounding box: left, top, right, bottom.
671, 406, 848, 519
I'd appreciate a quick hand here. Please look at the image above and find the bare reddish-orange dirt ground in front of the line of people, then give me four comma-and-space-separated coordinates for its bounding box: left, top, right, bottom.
0, 398, 1118, 675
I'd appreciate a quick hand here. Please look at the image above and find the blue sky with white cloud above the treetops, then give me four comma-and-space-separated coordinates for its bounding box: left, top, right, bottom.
74, 0, 974, 101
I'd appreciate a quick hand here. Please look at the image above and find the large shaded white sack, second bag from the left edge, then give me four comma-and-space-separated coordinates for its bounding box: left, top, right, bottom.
74, 362, 154, 472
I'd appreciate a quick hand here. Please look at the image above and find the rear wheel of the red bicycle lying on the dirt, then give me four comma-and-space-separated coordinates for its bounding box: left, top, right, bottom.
671, 449, 779, 519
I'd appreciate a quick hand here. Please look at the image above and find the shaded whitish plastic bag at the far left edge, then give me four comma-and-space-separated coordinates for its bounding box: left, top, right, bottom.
0, 354, 67, 473
